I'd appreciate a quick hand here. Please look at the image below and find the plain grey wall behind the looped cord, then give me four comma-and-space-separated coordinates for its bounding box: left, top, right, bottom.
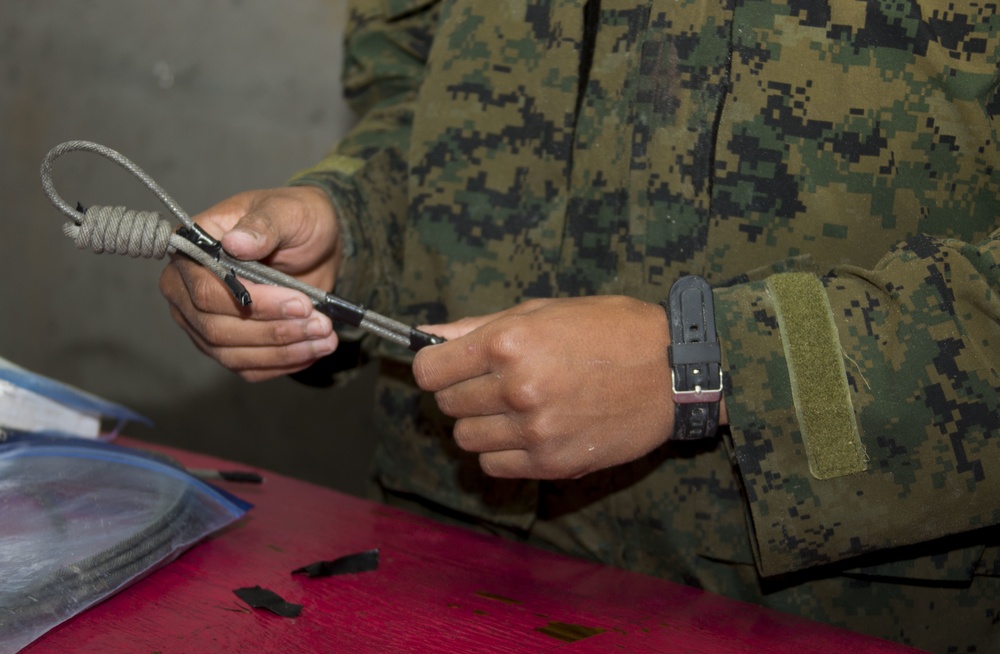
0, 0, 371, 493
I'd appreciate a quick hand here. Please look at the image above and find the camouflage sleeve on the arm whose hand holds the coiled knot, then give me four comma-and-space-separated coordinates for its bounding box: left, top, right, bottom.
289, 0, 437, 312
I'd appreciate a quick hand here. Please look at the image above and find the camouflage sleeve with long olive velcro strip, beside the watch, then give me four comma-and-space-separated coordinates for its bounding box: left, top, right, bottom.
715, 231, 1000, 576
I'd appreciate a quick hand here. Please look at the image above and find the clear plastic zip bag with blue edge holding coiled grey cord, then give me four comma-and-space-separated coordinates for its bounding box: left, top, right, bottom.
0, 434, 251, 654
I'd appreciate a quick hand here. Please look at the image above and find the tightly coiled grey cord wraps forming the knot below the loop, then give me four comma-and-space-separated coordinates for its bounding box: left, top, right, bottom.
63, 206, 173, 259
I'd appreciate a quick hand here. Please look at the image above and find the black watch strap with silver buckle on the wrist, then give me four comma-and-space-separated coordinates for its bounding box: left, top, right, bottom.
663, 276, 722, 440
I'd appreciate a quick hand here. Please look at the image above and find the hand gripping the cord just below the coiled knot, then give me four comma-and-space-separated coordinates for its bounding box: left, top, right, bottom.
160, 187, 341, 381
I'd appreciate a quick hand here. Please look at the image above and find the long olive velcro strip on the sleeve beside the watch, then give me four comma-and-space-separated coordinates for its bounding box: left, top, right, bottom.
767, 273, 868, 479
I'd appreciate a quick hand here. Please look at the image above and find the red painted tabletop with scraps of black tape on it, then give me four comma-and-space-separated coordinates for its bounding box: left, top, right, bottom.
23, 439, 914, 654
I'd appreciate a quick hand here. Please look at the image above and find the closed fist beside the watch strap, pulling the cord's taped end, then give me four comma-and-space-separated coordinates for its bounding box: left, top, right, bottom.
413, 296, 696, 479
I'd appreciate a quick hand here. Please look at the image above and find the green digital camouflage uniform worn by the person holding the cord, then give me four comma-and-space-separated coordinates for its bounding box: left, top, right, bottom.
293, 0, 1000, 652
